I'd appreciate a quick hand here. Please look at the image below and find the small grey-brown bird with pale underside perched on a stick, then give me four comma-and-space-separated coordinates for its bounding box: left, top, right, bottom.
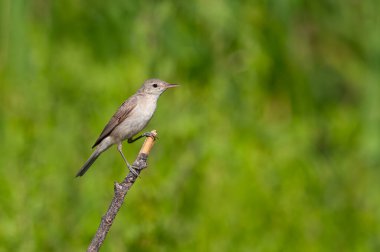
76, 79, 179, 177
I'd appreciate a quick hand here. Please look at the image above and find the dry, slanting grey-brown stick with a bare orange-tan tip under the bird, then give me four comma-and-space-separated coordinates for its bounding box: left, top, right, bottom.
87, 130, 157, 252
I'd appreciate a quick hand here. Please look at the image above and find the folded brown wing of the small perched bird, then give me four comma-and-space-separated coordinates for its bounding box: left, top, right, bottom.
92, 96, 137, 148
